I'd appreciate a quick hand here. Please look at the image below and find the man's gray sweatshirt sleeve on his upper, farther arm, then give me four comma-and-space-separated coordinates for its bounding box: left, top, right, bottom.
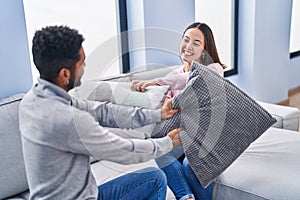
72, 97, 161, 128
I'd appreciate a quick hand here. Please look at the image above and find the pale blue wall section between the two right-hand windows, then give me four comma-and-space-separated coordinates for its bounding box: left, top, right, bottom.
229, 0, 300, 103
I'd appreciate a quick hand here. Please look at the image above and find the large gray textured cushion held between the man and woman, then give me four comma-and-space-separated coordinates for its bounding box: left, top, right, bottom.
152, 62, 276, 187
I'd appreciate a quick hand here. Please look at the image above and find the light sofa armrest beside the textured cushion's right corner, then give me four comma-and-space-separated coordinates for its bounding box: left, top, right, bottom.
258, 101, 300, 131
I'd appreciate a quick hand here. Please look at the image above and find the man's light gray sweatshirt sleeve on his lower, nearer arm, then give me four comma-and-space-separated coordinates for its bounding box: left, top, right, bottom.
67, 110, 173, 164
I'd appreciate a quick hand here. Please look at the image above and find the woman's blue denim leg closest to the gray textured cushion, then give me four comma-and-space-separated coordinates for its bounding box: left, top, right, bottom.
183, 158, 212, 200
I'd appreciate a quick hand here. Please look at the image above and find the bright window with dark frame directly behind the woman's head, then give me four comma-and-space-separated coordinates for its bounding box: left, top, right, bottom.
195, 0, 238, 76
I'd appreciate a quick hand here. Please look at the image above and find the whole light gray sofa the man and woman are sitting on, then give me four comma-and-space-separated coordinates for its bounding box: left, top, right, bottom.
0, 67, 300, 200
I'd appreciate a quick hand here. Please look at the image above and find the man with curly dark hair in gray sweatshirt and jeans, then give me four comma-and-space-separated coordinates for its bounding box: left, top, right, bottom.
20, 26, 181, 200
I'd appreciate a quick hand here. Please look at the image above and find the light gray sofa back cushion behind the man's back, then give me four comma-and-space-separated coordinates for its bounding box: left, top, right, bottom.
0, 94, 28, 199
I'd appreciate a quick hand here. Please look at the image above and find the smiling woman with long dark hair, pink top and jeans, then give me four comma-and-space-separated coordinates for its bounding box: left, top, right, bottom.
131, 22, 226, 200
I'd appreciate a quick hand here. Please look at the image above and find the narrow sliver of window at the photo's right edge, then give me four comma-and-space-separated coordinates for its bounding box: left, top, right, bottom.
290, 0, 300, 58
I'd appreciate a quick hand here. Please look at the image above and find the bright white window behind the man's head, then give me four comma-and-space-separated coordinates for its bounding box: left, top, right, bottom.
23, 0, 121, 81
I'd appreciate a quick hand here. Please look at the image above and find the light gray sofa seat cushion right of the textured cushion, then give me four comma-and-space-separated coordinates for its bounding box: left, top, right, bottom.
213, 127, 300, 200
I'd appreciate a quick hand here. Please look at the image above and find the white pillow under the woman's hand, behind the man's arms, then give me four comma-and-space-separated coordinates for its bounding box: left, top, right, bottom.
72, 81, 169, 137
